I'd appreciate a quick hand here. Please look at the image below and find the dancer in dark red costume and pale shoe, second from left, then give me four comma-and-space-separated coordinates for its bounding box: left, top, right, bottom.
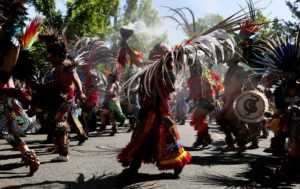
38, 28, 86, 161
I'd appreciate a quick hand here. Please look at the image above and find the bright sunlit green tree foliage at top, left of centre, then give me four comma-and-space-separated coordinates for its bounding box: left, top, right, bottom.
65, 0, 120, 38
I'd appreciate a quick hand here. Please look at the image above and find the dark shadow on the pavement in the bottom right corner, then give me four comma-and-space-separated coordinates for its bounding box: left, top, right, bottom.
187, 154, 300, 188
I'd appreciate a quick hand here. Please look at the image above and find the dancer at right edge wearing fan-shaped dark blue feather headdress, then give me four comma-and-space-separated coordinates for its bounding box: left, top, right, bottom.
248, 28, 300, 175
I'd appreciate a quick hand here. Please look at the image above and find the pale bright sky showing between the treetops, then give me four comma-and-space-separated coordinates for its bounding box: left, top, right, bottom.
31, 0, 293, 45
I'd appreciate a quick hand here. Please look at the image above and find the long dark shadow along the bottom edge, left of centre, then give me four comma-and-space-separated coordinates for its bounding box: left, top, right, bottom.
2, 172, 174, 189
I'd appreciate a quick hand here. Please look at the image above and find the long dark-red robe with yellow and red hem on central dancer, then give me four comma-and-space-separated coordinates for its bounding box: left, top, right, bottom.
118, 57, 191, 174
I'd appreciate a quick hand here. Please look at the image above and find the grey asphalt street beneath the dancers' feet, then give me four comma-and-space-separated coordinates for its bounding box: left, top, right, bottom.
0, 122, 300, 189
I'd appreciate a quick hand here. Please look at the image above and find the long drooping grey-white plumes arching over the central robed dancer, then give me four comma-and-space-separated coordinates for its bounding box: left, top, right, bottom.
124, 29, 236, 104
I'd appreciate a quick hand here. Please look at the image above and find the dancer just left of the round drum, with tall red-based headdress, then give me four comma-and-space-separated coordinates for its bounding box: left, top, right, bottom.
215, 0, 263, 153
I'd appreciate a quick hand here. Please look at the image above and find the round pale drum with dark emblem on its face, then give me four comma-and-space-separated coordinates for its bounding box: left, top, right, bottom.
233, 91, 269, 123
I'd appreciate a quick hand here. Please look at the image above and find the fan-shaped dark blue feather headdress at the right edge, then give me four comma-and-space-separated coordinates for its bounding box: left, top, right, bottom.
248, 32, 300, 79
